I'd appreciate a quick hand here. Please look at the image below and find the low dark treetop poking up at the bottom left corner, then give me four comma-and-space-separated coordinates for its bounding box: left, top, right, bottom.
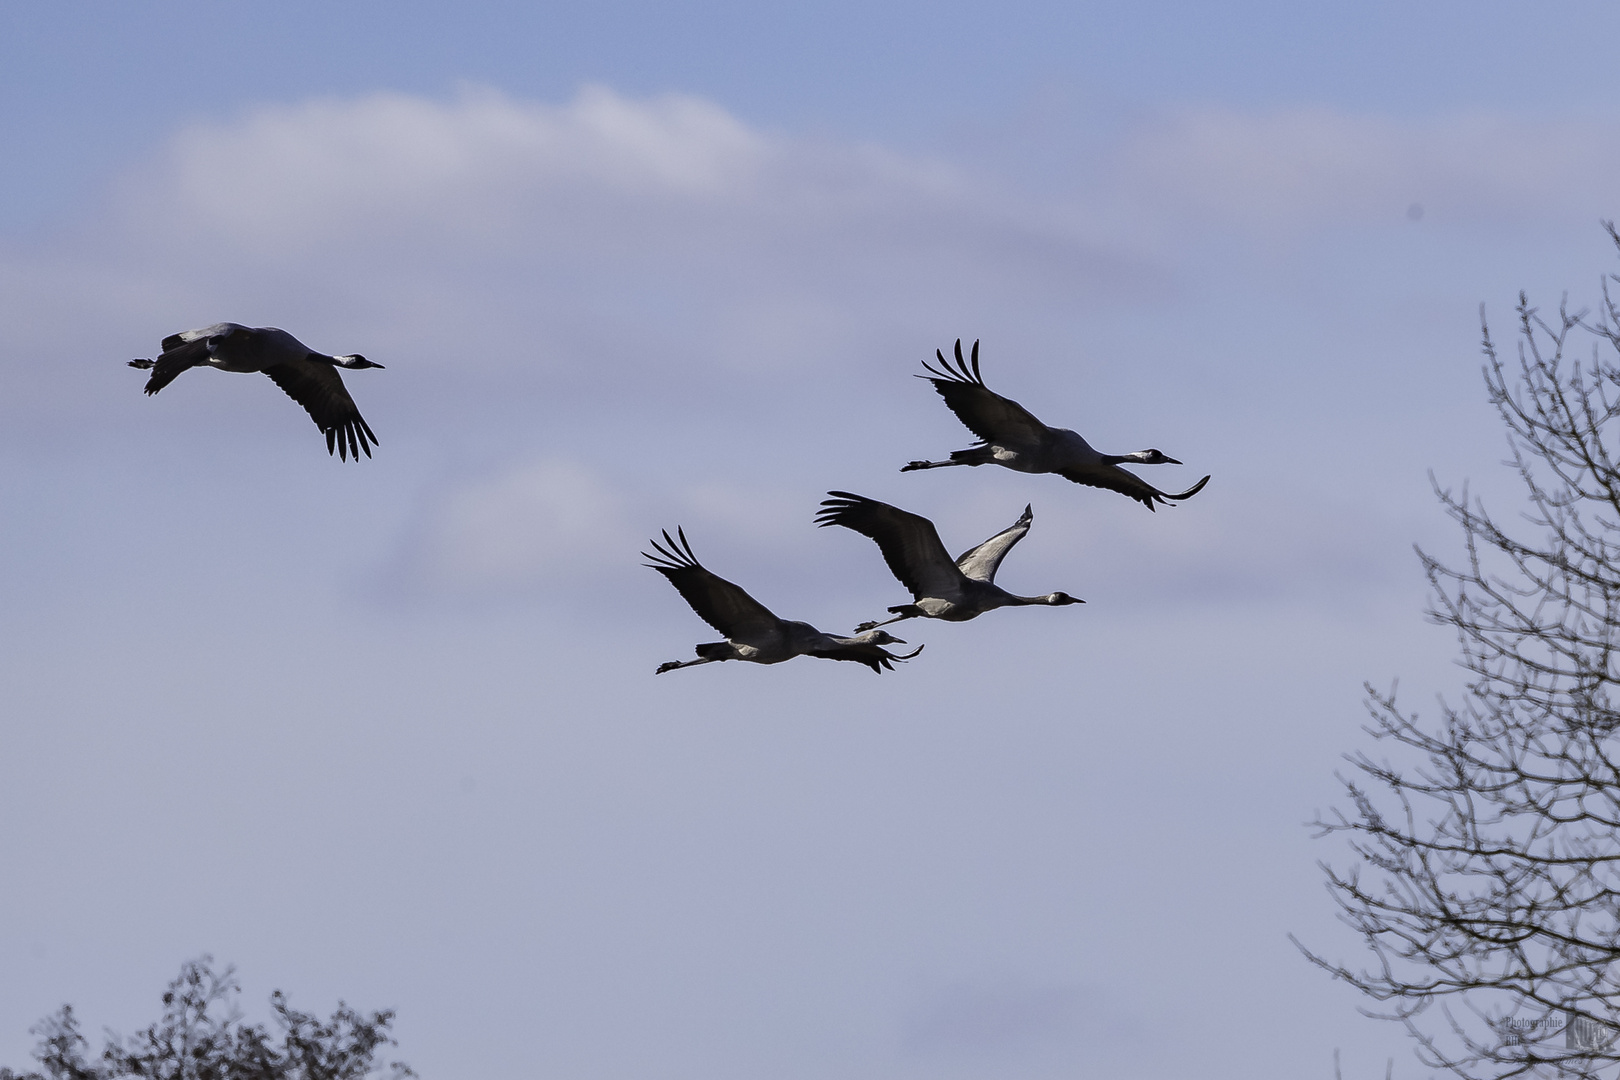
0, 957, 416, 1080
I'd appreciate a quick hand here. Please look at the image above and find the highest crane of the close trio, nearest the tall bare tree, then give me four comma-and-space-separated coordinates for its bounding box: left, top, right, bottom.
901, 338, 1210, 510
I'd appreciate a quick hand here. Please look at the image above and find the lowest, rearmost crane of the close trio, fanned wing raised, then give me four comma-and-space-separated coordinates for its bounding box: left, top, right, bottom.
642, 529, 922, 675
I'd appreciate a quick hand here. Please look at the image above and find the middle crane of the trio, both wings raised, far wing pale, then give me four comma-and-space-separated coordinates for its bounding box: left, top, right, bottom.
816, 491, 1085, 630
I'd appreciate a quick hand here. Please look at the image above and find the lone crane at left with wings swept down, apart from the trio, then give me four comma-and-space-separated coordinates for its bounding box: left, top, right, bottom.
130, 322, 382, 461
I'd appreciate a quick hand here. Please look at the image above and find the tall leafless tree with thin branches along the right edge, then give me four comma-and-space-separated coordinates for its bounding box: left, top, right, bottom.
1301, 223, 1620, 1078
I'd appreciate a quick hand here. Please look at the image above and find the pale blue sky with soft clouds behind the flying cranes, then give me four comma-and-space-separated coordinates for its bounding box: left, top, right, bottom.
0, 3, 1620, 1078
